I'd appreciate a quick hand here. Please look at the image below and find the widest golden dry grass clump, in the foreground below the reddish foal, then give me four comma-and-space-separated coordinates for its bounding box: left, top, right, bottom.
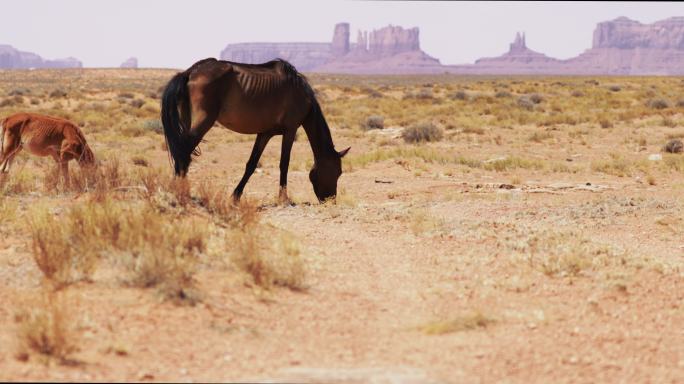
29, 199, 206, 304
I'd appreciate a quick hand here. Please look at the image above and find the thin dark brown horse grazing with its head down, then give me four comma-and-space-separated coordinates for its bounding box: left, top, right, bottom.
161, 58, 349, 201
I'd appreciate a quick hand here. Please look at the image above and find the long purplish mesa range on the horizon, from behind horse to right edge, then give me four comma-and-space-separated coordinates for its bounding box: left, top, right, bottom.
221, 17, 684, 75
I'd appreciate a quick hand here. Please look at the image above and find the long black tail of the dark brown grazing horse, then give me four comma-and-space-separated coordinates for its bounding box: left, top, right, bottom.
161, 71, 191, 176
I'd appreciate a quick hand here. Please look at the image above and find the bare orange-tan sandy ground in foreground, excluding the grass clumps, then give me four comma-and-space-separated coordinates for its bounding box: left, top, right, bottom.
0, 130, 684, 383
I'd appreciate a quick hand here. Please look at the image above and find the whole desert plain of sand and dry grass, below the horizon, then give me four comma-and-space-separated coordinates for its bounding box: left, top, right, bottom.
0, 69, 684, 383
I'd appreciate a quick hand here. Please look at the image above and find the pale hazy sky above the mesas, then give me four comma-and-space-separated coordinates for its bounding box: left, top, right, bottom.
0, 0, 684, 68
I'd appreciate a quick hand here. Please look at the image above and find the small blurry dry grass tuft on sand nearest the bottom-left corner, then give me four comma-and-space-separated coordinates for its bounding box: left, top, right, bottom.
14, 290, 78, 365
